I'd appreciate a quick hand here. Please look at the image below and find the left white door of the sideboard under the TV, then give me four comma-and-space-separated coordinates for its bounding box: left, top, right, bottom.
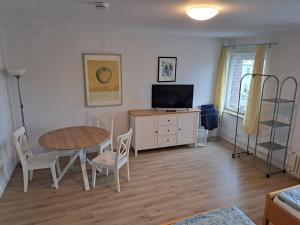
135, 116, 157, 150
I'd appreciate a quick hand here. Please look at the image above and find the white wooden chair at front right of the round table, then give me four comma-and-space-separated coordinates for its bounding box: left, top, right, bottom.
92, 129, 132, 192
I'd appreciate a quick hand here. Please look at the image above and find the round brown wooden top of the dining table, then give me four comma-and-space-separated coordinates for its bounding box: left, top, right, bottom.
39, 126, 109, 150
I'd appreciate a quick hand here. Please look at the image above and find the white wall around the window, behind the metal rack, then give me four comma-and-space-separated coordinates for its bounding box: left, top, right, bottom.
222, 30, 300, 162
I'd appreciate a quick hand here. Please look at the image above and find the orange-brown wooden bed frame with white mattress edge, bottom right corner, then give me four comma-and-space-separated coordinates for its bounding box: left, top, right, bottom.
263, 185, 300, 225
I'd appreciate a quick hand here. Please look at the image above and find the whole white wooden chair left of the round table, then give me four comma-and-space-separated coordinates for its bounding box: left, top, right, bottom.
13, 127, 61, 192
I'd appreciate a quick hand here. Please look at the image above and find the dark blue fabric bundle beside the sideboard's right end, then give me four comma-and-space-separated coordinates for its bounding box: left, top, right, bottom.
201, 104, 218, 130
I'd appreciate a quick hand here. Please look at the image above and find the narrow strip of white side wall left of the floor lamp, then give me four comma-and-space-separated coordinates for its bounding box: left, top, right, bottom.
0, 30, 18, 197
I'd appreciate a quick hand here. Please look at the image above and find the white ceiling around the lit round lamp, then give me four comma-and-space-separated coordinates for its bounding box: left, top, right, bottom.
0, 0, 300, 37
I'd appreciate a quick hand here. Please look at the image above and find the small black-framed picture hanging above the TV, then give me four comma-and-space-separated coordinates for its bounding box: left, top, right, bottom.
157, 57, 177, 82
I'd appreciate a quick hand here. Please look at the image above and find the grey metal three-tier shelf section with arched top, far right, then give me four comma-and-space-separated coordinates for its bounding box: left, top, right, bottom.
253, 77, 298, 178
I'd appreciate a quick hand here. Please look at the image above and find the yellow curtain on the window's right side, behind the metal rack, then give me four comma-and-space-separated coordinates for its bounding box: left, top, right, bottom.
243, 46, 266, 134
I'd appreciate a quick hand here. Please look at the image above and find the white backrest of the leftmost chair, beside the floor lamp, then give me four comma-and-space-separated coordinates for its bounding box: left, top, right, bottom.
13, 127, 31, 167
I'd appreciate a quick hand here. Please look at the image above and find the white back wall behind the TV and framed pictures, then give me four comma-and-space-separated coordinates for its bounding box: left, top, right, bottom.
4, 27, 222, 146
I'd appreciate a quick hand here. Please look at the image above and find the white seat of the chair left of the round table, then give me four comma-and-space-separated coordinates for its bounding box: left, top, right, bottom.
27, 152, 57, 169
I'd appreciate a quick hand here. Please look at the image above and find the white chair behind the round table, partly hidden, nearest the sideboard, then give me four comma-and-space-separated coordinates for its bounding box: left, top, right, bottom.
85, 113, 115, 154
